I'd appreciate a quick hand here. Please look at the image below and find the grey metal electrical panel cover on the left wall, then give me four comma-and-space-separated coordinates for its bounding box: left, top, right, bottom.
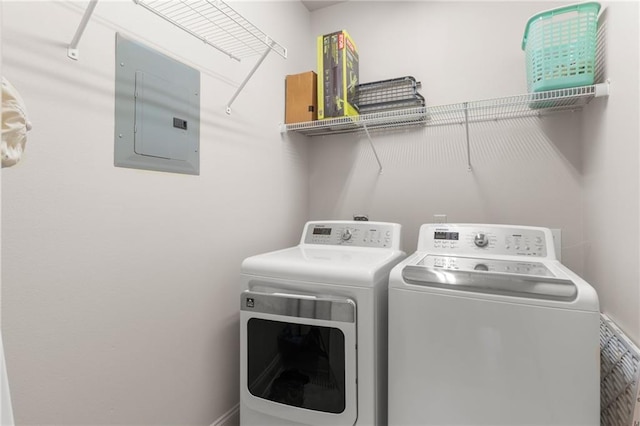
114, 34, 200, 175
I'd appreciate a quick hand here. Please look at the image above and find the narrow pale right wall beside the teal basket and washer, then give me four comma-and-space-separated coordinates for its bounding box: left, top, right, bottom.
583, 2, 640, 344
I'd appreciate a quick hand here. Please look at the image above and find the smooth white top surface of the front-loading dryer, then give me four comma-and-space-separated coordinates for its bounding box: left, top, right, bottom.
242, 246, 405, 287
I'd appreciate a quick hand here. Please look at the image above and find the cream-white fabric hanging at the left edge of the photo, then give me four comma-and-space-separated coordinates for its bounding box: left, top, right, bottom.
0, 77, 31, 167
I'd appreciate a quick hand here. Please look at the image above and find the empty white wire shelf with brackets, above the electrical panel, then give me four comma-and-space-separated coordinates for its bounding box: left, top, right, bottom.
67, 0, 287, 114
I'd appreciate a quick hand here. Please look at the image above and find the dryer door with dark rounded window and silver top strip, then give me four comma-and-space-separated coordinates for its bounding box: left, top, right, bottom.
240, 291, 357, 425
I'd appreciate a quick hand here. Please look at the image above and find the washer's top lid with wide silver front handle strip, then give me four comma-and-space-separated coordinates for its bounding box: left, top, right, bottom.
402, 255, 578, 302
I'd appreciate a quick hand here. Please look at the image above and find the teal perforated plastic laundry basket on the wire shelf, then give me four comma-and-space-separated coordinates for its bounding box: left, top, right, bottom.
522, 2, 600, 92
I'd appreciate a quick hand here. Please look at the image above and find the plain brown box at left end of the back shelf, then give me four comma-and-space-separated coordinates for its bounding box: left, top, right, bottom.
284, 71, 318, 124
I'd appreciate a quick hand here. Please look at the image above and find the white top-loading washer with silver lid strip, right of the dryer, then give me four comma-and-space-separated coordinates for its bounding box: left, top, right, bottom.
389, 224, 600, 426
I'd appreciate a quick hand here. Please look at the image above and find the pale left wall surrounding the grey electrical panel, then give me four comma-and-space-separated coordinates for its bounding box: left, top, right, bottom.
2, 1, 314, 425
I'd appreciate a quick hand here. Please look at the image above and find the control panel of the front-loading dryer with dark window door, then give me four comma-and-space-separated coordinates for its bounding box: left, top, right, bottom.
302, 221, 400, 249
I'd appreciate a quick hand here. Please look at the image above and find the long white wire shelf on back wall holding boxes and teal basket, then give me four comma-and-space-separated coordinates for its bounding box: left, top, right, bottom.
282, 83, 609, 136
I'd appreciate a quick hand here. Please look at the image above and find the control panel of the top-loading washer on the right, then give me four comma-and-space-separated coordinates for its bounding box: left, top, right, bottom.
418, 223, 556, 259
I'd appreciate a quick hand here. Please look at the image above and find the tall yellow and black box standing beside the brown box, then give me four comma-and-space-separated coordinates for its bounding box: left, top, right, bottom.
318, 30, 358, 120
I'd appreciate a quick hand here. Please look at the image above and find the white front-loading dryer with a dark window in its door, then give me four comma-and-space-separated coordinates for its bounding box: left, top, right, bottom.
240, 221, 405, 426
